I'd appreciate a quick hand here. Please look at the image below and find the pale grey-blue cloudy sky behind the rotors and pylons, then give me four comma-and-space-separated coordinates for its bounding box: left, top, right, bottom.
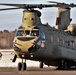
0, 0, 76, 30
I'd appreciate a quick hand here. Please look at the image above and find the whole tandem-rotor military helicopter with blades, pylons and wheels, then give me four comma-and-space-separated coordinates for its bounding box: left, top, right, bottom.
0, 1, 76, 70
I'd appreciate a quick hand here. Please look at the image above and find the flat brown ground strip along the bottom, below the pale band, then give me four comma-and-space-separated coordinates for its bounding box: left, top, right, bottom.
0, 67, 76, 75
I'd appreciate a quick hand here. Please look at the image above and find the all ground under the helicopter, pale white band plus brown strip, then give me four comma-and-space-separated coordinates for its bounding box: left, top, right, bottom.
0, 50, 76, 75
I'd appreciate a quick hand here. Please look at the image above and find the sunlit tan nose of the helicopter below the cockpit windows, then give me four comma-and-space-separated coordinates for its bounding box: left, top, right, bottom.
14, 37, 38, 52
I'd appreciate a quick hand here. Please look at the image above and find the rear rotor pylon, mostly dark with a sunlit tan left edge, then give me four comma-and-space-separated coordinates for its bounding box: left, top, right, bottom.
55, 8, 71, 30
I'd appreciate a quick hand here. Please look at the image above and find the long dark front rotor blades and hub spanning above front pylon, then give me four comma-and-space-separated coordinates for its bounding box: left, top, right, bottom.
0, 3, 56, 9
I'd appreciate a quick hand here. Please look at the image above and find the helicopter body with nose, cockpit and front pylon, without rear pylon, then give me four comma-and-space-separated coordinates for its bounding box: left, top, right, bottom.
14, 10, 76, 68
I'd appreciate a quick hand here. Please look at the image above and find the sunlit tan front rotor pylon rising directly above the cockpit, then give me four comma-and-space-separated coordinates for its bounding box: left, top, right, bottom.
22, 10, 41, 29
